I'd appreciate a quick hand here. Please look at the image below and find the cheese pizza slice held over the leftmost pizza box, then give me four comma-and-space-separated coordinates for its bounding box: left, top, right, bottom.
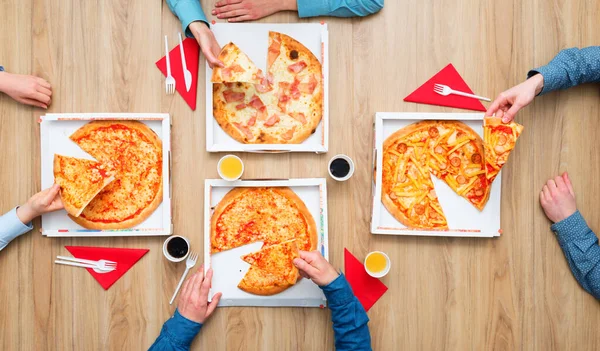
54, 154, 116, 217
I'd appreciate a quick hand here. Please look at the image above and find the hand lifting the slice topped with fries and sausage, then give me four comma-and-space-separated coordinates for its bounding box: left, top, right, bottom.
485, 74, 544, 123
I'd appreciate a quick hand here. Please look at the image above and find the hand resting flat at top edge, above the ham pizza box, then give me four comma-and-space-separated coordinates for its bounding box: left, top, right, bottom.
212, 0, 298, 22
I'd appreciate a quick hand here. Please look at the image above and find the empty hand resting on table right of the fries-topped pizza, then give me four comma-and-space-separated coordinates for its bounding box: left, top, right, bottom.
540, 172, 577, 223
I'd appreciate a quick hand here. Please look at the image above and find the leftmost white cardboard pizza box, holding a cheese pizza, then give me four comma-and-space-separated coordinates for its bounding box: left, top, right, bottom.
40, 113, 173, 237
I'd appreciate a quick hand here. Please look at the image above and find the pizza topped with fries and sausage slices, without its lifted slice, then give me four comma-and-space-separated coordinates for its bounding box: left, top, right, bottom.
381, 121, 490, 229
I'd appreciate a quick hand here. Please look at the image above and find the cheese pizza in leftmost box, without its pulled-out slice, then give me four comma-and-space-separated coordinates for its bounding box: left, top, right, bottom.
70, 121, 163, 229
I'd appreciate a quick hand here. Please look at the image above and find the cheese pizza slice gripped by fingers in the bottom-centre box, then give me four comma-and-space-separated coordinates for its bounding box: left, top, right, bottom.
242, 239, 299, 284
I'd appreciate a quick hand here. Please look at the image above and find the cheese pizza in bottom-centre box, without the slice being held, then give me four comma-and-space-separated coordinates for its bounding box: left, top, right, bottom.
211, 187, 318, 295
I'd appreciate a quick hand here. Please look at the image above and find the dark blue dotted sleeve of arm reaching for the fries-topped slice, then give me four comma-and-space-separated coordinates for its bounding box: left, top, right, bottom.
527, 46, 600, 95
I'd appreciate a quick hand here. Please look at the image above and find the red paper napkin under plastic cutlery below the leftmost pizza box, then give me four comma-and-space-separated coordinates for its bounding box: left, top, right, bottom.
65, 246, 149, 290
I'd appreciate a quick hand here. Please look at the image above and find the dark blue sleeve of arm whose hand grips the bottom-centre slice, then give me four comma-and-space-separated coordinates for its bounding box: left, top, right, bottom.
321, 274, 371, 351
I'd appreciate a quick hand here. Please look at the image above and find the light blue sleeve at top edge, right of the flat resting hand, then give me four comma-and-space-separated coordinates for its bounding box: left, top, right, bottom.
297, 0, 384, 17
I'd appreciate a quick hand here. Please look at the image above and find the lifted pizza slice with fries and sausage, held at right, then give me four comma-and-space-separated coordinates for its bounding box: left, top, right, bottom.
483, 117, 524, 183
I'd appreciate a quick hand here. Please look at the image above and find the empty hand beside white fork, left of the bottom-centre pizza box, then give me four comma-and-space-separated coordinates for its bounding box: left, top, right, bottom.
177, 265, 222, 324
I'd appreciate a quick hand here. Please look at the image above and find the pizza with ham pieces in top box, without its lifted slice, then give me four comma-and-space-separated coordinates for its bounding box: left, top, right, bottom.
213, 32, 323, 144
